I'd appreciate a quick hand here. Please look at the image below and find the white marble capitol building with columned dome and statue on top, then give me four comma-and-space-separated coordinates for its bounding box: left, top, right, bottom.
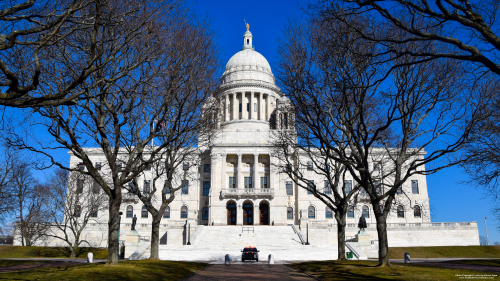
52, 30, 479, 260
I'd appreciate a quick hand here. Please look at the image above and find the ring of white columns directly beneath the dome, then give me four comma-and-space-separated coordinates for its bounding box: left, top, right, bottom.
223, 92, 276, 122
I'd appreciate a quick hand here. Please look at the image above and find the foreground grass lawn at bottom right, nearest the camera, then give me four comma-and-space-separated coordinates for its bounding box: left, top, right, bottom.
292, 261, 498, 281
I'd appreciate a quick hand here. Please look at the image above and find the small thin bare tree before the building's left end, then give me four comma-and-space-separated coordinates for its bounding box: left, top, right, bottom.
43, 169, 107, 258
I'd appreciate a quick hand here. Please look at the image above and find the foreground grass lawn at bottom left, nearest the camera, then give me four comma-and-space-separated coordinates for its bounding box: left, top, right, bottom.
0, 260, 207, 281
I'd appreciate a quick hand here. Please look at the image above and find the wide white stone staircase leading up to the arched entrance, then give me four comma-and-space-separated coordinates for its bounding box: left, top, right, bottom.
160, 225, 337, 261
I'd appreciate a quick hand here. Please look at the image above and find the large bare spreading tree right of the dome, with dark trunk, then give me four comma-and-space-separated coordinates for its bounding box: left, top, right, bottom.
279, 14, 484, 266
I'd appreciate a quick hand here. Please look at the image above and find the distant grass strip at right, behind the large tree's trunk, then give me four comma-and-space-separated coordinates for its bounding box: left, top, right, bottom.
389, 246, 500, 259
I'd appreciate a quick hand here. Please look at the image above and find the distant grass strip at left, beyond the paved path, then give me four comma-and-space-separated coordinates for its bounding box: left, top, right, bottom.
0, 246, 108, 259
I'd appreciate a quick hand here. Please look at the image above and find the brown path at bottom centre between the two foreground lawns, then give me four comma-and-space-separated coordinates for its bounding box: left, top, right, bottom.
185, 264, 315, 281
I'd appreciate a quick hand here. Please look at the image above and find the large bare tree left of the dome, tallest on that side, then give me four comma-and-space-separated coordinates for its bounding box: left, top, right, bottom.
3, 1, 218, 264
